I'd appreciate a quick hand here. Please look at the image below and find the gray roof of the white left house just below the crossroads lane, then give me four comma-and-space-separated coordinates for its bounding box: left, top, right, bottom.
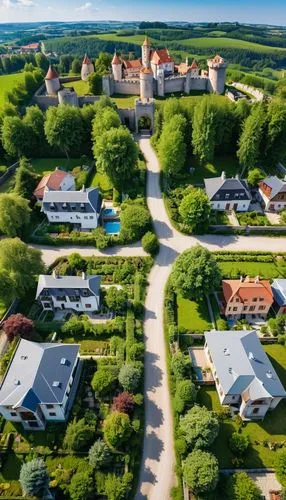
36, 274, 101, 299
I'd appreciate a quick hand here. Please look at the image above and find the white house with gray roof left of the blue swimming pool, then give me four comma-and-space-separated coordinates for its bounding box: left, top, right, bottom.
41, 187, 102, 229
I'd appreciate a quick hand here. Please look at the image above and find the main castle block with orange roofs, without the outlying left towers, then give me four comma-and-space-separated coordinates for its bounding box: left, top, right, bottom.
102, 37, 227, 99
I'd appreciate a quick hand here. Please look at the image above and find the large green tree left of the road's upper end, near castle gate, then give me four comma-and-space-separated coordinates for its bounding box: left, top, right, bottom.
93, 126, 138, 192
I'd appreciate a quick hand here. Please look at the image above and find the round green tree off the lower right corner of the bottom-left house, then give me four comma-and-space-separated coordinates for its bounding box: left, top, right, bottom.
64, 418, 94, 451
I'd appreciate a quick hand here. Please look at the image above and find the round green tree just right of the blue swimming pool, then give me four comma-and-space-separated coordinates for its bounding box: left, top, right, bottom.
120, 205, 151, 242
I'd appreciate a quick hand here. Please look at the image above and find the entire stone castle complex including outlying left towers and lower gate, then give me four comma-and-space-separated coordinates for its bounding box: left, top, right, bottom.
34, 37, 227, 132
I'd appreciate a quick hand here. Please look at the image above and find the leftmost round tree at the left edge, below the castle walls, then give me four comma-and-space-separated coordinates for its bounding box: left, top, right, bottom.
2, 116, 31, 157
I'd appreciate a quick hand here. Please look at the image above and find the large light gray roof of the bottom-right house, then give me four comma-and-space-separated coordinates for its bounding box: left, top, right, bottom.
205, 331, 286, 400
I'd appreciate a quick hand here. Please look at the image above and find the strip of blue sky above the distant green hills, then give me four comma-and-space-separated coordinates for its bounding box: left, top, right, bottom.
0, 0, 286, 25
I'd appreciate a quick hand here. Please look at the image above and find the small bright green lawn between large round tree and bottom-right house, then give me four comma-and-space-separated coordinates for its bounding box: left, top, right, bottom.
177, 297, 211, 332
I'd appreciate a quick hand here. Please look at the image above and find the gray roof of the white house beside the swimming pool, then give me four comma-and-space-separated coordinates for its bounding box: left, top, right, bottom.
43, 188, 101, 212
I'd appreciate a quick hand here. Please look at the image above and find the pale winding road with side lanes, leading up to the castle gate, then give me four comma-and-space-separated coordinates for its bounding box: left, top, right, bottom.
37, 137, 286, 500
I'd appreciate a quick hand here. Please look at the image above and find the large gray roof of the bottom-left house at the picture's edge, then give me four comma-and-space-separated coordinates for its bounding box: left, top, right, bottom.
0, 339, 80, 412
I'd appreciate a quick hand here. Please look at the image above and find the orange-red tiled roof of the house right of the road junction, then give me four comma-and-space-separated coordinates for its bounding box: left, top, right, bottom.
222, 276, 273, 305
